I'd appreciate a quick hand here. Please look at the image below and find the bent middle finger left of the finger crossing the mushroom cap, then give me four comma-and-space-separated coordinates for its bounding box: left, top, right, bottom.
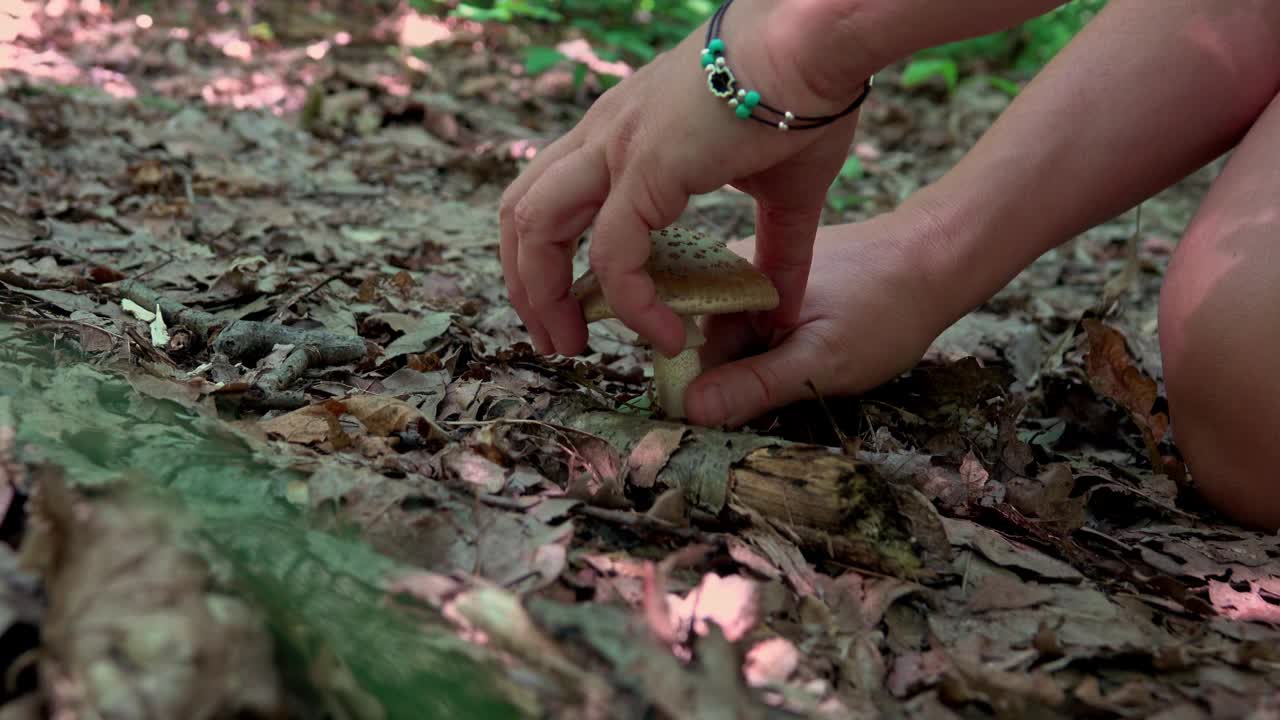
515, 149, 609, 355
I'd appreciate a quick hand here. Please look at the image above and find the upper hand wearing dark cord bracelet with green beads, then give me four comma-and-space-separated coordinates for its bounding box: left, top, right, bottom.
502, 0, 865, 356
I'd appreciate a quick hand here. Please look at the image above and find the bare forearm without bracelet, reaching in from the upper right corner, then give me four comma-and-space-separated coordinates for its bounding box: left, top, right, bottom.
902, 0, 1280, 320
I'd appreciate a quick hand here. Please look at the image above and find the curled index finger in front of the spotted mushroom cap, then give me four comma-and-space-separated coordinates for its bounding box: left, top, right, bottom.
590, 173, 689, 357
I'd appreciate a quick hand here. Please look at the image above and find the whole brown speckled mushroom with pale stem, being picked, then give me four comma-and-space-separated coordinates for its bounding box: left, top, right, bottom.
573, 227, 778, 418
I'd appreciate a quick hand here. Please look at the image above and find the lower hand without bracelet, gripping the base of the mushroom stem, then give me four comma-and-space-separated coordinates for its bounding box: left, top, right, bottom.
685, 213, 964, 427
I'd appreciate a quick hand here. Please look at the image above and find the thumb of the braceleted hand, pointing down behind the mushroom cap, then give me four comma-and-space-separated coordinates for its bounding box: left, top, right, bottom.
755, 201, 822, 328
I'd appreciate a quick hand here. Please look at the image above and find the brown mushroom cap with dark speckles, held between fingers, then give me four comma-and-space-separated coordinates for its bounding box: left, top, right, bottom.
573, 227, 778, 323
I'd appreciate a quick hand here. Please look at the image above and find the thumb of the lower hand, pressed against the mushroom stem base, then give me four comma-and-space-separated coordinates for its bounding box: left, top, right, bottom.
685, 336, 824, 427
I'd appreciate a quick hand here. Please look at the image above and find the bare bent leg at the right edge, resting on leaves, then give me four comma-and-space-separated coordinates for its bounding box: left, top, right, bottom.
1160, 89, 1280, 529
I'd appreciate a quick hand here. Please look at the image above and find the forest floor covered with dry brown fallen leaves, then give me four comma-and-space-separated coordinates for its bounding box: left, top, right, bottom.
0, 3, 1280, 720
